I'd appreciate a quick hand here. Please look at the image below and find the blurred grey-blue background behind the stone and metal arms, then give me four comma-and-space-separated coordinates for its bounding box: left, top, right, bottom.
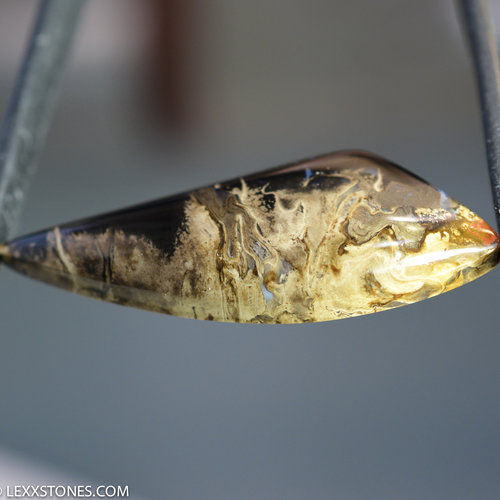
0, 0, 500, 500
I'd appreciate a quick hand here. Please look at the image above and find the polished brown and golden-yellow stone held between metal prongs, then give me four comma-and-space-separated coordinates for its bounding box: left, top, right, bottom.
0, 152, 499, 323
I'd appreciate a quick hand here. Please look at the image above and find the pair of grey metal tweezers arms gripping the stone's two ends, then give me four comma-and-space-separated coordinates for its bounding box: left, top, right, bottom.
0, 0, 500, 242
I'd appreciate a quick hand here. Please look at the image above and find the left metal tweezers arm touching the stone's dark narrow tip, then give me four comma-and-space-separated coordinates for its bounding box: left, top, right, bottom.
0, 0, 84, 242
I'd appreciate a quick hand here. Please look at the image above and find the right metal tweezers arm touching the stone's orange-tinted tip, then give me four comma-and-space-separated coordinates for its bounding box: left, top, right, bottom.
458, 0, 500, 229
